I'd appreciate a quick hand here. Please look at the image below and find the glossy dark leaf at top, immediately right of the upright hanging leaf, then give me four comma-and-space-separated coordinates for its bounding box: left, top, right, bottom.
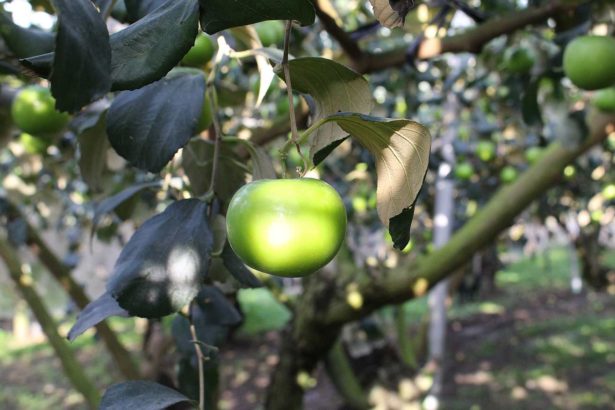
111, 0, 199, 91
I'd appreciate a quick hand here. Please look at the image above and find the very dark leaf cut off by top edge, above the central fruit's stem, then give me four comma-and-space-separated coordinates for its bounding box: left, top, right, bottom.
199, 0, 315, 34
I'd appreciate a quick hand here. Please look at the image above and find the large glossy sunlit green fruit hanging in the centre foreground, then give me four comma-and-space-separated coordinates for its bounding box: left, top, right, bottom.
226, 178, 346, 277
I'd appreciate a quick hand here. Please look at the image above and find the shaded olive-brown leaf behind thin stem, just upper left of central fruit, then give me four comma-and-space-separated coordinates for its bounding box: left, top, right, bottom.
182, 139, 246, 203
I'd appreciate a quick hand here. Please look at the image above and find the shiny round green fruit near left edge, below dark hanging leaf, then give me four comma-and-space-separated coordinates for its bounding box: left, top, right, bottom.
11, 85, 70, 134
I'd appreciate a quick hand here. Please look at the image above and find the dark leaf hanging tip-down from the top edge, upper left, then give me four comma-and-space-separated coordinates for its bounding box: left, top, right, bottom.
50, 0, 111, 112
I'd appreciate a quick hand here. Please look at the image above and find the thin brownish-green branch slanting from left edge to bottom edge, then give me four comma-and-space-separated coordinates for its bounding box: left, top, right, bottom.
0, 238, 100, 409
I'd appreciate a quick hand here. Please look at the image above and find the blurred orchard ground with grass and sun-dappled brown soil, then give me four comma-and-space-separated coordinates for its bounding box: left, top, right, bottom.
0, 248, 615, 410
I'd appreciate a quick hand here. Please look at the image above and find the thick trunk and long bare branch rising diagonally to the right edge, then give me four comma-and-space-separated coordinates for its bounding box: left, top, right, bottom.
266, 110, 615, 410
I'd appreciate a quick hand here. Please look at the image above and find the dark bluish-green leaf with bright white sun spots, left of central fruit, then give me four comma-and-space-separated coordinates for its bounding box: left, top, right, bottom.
107, 199, 213, 318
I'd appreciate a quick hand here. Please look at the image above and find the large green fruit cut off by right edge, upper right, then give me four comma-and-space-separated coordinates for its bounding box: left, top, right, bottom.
564, 36, 615, 90
